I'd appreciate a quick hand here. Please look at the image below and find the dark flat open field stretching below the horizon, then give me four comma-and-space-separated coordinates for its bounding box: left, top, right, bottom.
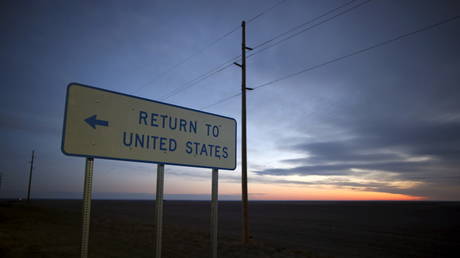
0, 200, 460, 257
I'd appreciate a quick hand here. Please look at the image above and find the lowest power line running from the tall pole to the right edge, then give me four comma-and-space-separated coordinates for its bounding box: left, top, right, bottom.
253, 15, 460, 89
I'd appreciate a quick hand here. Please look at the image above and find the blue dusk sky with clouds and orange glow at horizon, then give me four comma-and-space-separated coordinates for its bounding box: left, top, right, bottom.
0, 0, 460, 201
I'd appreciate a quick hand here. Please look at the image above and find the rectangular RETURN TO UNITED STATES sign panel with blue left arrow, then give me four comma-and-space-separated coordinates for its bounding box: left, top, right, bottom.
61, 83, 236, 170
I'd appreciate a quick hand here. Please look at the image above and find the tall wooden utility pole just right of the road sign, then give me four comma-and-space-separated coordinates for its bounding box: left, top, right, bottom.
234, 21, 253, 244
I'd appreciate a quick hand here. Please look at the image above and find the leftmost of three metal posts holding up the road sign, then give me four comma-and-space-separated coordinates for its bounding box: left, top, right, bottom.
80, 158, 94, 258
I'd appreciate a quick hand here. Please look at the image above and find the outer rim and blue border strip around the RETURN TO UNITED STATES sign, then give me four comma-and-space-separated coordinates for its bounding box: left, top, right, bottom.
61, 82, 238, 170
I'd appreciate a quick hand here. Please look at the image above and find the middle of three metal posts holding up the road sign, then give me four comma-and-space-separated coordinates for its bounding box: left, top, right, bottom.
155, 164, 165, 258
